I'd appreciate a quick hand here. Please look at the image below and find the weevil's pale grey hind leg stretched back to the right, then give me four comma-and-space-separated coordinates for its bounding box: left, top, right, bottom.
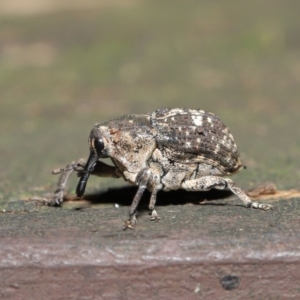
182, 176, 273, 210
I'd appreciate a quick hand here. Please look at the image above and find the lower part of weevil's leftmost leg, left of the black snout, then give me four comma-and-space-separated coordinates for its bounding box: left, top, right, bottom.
47, 159, 86, 206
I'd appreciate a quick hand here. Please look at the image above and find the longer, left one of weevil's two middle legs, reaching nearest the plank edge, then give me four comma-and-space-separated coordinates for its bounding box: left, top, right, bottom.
123, 169, 151, 230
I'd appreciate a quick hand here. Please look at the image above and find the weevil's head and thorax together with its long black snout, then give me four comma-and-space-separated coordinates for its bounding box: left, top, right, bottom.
76, 114, 156, 197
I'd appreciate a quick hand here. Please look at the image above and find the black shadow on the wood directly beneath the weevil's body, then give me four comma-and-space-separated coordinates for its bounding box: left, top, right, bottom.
84, 186, 233, 207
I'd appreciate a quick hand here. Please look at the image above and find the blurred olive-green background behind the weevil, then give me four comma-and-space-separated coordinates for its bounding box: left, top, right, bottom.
0, 0, 300, 207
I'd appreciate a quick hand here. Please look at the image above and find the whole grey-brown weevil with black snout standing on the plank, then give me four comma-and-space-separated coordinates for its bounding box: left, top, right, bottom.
50, 108, 273, 229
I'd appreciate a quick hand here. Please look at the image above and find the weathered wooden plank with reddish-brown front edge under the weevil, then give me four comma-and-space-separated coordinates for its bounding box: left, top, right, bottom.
0, 188, 300, 300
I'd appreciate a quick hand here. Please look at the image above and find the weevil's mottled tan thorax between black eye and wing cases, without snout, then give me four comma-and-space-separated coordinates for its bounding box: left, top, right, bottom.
91, 114, 156, 181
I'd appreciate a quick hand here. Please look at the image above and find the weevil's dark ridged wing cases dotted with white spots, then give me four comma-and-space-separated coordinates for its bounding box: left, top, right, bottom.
151, 108, 242, 174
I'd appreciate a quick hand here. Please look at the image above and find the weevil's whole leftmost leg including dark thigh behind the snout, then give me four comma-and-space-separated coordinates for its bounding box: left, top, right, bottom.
51, 159, 120, 205
